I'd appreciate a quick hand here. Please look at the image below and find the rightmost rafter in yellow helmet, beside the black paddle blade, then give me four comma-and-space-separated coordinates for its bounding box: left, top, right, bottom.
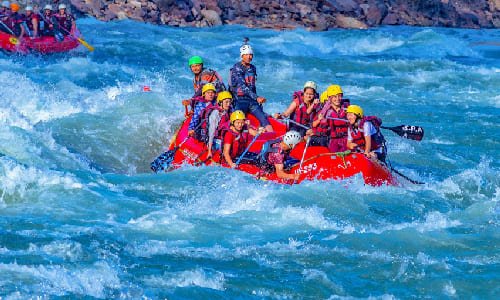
346, 105, 387, 162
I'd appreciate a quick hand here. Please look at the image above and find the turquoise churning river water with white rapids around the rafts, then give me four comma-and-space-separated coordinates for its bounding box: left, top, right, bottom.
0, 19, 500, 299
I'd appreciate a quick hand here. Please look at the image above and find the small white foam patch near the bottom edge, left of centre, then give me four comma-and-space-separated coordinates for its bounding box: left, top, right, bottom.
142, 268, 226, 291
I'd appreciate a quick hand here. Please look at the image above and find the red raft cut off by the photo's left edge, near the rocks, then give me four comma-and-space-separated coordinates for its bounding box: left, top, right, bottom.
0, 32, 80, 54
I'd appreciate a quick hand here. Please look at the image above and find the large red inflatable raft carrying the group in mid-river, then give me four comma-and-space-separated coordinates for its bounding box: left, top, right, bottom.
153, 115, 399, 186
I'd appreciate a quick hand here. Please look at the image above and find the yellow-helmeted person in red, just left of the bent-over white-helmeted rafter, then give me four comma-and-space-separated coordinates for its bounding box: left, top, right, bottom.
222, 110, 264, 168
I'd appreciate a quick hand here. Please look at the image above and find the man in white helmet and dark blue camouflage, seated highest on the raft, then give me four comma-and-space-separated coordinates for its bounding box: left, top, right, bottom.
229, 43, 273, 132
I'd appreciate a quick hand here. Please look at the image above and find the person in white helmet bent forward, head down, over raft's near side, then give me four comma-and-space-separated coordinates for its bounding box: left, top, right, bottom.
259, 130, 302, 180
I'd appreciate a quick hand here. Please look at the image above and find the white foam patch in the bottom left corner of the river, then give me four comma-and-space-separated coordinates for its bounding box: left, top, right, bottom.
0, 261, 121, 298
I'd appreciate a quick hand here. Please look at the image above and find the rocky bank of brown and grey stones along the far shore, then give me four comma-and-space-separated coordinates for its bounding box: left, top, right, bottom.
62, 0, 500, 31
